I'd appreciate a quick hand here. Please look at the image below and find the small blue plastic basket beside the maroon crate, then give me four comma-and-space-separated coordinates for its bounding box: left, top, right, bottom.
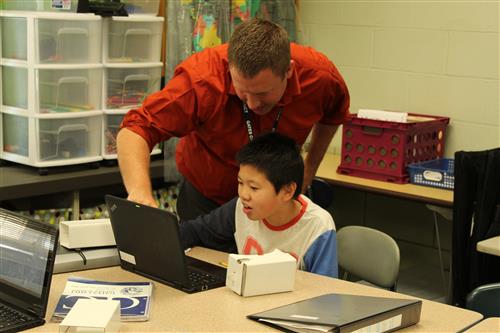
408, 158, 455, 190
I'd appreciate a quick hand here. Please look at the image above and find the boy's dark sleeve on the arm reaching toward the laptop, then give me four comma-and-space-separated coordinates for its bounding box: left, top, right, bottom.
180, 198, 238, 253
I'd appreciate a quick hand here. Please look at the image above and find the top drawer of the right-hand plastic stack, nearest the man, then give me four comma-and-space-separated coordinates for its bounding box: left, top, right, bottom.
104, 16, 163, 63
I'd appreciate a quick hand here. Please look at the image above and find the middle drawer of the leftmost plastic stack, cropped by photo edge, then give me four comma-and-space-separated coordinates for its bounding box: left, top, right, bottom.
2, 66, 28, 109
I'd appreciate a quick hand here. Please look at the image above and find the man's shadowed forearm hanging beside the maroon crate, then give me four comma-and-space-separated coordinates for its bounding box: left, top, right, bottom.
302, 123, 338, 193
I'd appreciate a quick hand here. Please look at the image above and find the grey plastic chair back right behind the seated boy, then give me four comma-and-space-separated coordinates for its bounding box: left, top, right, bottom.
337, 226, 399, 291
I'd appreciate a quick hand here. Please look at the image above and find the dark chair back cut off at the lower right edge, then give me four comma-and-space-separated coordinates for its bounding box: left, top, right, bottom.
465, 282, 500, 318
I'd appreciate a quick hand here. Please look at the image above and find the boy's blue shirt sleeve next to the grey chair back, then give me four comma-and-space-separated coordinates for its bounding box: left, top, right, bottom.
304, 230, 338, 278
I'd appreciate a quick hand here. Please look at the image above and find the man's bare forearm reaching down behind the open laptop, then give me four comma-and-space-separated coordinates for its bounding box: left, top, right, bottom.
116, 128, 157, 207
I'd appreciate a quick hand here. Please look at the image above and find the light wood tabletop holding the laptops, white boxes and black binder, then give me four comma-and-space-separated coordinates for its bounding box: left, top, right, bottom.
31, 248, 482, 332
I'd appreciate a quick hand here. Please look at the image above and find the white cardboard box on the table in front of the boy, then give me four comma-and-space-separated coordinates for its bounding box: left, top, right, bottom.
226, 250, 297, 296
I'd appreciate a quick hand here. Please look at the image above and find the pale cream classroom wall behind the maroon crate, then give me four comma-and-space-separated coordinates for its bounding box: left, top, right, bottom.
300, 0, 500, 157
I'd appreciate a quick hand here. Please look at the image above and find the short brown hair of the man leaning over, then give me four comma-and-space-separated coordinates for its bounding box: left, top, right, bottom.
228, 18, 290, 79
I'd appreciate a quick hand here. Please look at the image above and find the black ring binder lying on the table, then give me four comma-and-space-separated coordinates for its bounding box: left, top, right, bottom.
248, 294, 422, 333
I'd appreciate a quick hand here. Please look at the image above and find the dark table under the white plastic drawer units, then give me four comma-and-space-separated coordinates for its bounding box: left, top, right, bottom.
0, 159, 164, 220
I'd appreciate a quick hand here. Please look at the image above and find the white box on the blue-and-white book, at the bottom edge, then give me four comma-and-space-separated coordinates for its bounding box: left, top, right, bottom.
59, 299, 120, 333
